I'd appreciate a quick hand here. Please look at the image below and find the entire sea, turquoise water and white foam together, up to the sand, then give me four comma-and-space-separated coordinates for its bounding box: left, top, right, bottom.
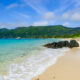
0, 39, 69, 80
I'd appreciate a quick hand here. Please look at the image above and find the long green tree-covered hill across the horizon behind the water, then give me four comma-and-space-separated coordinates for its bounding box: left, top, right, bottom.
0, 25, 80, 38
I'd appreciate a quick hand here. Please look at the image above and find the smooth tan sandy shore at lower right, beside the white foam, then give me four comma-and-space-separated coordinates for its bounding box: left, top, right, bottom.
32, 41, 80, 80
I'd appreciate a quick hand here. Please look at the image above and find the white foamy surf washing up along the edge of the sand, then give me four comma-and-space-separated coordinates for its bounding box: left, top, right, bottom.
0, 48, 69, 80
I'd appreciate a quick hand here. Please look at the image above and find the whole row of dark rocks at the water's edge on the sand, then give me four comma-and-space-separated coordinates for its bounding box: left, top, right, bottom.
44, 40, 79, 48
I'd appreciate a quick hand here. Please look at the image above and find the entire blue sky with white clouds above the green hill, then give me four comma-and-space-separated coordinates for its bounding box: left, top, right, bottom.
0, 0, 80, 28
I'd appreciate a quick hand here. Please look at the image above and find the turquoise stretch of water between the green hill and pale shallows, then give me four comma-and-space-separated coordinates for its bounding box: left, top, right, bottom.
0, 39, 56, 62
